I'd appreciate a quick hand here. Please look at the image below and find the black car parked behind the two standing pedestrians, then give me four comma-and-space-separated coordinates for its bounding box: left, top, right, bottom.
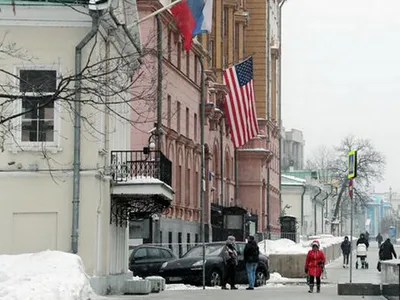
159, 242, 269, 286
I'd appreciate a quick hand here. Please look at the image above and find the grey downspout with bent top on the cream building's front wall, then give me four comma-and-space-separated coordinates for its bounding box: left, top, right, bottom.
71, 12, 101, 254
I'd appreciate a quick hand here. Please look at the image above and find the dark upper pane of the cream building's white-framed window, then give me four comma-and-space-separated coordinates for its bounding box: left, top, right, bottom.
19, 70, 57, 93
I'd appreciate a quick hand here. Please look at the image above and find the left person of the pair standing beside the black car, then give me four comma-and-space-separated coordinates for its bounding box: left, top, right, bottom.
221, 235, 238, 290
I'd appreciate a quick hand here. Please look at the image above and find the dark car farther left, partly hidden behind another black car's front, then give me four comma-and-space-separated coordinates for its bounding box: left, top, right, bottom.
129, 245, 177, 278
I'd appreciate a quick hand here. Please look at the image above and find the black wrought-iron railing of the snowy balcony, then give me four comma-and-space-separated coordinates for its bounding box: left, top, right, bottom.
111, 149, 172, 186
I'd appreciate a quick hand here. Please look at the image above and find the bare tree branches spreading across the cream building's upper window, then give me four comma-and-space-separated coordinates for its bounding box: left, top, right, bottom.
0, 17, 164, 156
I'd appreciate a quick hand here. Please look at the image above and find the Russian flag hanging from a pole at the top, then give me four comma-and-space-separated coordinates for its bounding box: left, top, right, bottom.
171, 0, 213, 51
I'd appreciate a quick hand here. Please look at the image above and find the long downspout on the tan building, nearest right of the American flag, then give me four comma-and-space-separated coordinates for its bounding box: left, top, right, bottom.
267, 1, 274, 239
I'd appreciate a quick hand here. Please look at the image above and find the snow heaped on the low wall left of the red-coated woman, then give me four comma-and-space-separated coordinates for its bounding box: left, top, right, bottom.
258, 239, 309, 255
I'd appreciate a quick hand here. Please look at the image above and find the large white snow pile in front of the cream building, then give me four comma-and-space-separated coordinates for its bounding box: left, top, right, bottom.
0, 251, 96, 300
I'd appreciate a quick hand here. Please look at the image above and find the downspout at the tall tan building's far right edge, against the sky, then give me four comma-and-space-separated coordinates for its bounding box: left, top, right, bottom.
278, 0, 286, 220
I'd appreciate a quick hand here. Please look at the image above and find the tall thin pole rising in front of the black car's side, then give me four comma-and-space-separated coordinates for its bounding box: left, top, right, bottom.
199, 56, 206, 290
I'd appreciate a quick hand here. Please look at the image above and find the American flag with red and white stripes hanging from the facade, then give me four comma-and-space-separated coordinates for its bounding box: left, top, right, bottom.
224, 57, 259, 148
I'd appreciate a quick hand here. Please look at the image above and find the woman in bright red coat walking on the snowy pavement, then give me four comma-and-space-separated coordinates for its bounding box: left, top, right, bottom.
304, 240, 325, 293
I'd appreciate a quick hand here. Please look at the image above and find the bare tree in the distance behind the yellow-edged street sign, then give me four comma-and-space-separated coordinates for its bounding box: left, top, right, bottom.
307, 136, 386, 232
